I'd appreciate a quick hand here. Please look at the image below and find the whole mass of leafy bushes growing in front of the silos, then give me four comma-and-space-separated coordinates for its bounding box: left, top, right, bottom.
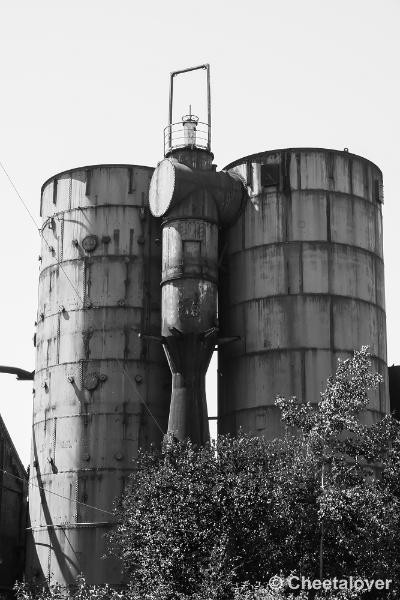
18, 348, 400, 600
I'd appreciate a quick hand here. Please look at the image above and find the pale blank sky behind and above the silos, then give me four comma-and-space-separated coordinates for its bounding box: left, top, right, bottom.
0, 0, 400, 464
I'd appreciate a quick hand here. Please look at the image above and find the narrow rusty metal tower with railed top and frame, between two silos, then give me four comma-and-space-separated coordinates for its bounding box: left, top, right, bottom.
149, 65, 246, 444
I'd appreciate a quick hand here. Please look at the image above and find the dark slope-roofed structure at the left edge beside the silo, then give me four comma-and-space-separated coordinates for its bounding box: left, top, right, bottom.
0, 416, 28, 595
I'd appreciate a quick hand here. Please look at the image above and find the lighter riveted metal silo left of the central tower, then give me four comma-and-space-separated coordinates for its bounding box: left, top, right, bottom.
27, 165, 171, 584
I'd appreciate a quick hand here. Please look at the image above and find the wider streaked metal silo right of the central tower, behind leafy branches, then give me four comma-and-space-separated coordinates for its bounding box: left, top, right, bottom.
218, 148, 388, 438
